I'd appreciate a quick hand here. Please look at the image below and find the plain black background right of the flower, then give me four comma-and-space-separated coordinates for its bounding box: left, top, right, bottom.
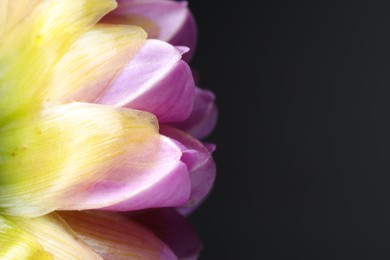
189, 0, 390, 260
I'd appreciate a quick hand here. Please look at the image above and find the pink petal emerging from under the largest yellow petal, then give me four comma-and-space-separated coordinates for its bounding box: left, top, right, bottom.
65, 136, 191, 211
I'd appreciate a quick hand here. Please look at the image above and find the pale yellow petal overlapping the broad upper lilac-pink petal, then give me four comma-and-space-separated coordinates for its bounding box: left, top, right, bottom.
46, 24, 146, 103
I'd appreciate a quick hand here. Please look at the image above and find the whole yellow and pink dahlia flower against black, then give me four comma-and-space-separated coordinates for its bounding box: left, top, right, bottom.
0, 0, 217, 259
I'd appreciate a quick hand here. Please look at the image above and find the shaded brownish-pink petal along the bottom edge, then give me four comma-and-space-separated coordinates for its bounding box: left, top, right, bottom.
59, 211, 177, 260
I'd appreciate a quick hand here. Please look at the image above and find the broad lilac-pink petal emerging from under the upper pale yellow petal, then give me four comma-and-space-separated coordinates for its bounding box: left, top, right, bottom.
98, 40, 195, 123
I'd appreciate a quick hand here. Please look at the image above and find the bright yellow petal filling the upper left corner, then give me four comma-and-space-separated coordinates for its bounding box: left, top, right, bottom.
0, 0, 116, 124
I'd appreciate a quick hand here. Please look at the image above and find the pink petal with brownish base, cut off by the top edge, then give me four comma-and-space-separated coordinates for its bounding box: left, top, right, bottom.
103, 0, 197, 60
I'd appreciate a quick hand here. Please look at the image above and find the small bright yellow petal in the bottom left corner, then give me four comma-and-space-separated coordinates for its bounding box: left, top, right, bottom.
0, 216, 54, 260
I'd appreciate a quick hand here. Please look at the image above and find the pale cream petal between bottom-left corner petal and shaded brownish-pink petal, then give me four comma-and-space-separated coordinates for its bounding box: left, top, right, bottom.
10, 213, 103, 260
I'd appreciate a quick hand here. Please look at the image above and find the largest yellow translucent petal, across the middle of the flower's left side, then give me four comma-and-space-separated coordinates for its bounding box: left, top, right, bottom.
0, 103, 158, 216
